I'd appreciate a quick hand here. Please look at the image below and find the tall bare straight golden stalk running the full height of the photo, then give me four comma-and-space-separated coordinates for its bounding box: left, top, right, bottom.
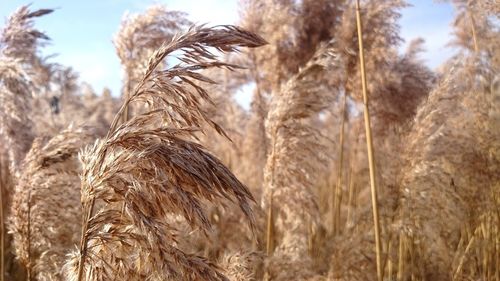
356, 0, 384, 281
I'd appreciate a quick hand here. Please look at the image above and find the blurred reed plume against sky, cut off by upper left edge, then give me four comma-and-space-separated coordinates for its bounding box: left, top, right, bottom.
0, 6, 52, 171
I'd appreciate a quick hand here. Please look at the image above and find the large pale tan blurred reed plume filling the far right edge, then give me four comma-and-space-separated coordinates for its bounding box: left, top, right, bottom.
396, 52, 499, 279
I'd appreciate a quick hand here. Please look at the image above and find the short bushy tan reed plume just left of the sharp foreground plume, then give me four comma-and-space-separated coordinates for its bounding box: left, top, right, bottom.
9, 128, 91, 280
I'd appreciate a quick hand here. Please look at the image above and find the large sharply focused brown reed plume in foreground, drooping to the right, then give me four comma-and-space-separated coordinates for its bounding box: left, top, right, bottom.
67, 26, 265, 280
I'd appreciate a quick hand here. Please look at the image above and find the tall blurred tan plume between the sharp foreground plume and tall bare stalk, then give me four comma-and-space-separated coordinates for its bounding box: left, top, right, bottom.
262, 42, 339, 280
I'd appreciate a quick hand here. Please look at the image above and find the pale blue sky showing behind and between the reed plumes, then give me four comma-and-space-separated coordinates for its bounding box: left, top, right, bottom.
0, 0, 453, 104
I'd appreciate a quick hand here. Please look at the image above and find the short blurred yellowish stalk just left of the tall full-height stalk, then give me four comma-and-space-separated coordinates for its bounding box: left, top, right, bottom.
332, 93, 347, 234
